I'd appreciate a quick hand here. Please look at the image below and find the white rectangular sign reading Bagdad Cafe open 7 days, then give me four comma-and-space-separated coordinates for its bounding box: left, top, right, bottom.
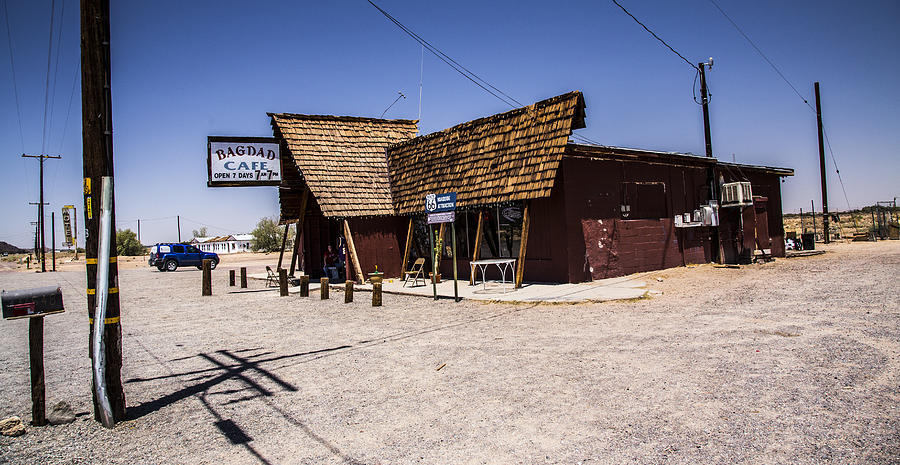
207, 136, 281, 186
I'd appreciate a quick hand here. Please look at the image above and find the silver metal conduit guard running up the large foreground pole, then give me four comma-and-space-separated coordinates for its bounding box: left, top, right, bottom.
93, 176, 116, 428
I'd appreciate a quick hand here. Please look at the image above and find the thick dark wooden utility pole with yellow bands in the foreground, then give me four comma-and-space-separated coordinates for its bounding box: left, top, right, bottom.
81, 0, 125, 421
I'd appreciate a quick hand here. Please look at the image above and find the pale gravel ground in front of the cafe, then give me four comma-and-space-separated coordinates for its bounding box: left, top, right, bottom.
0, 241, 900, 465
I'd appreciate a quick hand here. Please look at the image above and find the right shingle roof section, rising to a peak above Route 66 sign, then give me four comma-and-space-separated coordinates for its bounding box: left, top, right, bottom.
387, 91, 585, 215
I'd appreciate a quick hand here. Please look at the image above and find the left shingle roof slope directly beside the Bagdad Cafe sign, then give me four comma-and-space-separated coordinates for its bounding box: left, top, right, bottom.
268, 113, 418, 218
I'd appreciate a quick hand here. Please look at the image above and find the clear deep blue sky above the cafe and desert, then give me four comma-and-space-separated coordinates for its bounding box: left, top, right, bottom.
0, 0, 900, 247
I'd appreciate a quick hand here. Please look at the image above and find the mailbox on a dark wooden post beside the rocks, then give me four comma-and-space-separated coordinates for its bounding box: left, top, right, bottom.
0, 286, 65, 426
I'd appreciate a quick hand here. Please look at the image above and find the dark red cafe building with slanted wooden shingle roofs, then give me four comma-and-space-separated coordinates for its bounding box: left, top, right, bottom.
269, 92, 793, 283
